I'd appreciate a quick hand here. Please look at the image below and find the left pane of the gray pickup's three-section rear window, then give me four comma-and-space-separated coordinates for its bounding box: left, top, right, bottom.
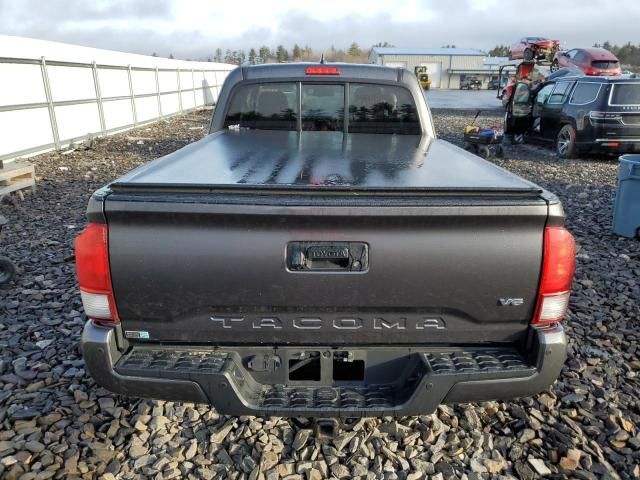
224, 83, 298, 130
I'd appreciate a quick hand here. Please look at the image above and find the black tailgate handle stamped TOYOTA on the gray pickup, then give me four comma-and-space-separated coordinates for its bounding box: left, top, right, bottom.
287, 242, 369, 273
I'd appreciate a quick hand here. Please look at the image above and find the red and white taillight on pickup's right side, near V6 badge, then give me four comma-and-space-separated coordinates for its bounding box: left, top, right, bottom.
531, 227, 576, 327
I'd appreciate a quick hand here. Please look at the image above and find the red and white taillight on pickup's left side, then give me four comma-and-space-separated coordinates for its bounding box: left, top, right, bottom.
76, 223, 120, 323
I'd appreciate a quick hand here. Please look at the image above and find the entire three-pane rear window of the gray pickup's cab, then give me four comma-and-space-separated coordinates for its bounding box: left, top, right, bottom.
224, 77, 428, 135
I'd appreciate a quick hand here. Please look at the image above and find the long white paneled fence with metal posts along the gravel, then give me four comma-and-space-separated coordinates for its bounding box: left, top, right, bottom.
0, 57, 235, 160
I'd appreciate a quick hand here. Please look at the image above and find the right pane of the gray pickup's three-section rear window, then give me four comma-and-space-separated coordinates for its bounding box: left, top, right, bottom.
349, 83, 421, 135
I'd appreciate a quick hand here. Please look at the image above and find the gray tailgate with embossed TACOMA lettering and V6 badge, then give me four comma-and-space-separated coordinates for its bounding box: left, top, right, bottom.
105, 194, 547, 345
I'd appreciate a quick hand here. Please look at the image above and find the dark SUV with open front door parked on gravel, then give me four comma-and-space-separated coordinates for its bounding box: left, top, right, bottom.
504, 71, 640, 158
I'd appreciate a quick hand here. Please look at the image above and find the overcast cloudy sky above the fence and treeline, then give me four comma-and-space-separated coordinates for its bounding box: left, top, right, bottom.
0, 0, 640, 59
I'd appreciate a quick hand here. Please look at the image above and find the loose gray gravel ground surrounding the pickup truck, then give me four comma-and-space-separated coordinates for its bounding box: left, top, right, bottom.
0, 110, 640, 480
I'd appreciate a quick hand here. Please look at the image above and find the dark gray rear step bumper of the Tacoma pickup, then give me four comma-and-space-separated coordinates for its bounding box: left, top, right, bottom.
81, 321, 566, 417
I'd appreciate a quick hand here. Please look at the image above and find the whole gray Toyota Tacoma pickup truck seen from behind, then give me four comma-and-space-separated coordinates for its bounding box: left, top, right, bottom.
76, 64, 575, 417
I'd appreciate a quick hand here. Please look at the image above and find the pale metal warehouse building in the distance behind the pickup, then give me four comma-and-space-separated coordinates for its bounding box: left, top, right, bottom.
369, 47, 497, 88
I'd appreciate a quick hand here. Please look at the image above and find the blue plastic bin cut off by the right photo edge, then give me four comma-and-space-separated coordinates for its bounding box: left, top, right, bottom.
613, 154, 640, 238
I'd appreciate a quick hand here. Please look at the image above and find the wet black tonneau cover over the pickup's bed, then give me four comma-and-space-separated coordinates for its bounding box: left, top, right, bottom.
111, 130, 542, 194
